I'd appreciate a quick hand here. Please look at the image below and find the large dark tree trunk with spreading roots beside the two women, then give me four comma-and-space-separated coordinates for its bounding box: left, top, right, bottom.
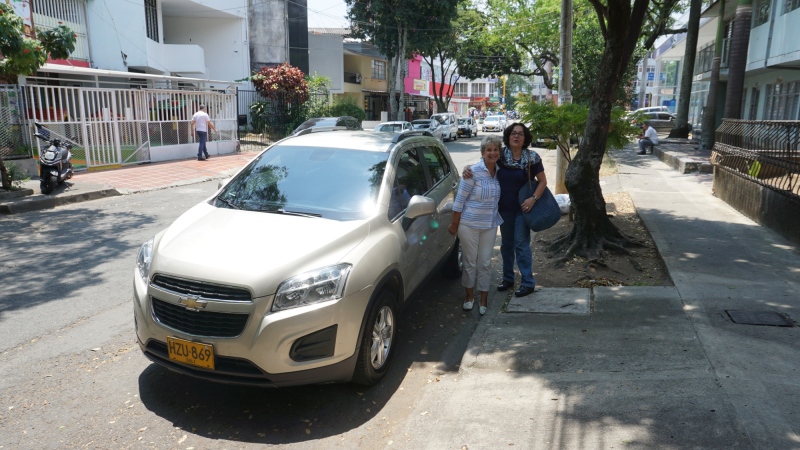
550, 0, 648, 263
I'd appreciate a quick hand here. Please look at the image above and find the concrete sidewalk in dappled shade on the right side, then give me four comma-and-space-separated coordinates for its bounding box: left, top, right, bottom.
395, 147, 800, 450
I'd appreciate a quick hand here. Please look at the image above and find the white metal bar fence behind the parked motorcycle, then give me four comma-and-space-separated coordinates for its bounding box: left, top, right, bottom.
23, 86, 236, 169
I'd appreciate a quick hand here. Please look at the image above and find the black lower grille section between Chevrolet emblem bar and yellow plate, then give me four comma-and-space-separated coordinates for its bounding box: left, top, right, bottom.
152, 298, 250, 338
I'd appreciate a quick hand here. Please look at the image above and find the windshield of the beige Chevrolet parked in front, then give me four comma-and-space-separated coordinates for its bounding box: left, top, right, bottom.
215, 146, 388, 220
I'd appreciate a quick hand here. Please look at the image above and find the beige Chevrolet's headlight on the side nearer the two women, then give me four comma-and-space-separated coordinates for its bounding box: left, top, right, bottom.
272, 264, 351, 311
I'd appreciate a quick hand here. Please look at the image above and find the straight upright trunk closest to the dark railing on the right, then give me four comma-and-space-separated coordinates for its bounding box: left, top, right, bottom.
722, 0, 753, 119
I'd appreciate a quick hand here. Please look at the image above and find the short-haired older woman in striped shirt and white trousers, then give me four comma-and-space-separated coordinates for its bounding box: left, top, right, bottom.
448, 136, 503, 315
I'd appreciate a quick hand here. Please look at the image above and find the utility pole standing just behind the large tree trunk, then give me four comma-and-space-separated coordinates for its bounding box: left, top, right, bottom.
555, 0, 572, 194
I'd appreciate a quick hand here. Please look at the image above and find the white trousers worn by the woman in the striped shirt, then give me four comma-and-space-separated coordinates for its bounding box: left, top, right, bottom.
458, 225, 497, 292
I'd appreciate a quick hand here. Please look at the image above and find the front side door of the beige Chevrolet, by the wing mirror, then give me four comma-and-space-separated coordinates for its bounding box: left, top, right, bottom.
388, 145, 433, 293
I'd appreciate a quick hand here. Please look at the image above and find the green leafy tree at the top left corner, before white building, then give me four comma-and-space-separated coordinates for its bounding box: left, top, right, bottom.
0, 3, 75, 190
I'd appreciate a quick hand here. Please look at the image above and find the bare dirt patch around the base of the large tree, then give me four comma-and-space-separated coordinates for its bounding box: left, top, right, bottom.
533, 192, 673, 287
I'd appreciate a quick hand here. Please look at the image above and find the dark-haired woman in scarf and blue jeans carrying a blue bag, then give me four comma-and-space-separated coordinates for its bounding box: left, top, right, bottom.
462, 122, 547, 297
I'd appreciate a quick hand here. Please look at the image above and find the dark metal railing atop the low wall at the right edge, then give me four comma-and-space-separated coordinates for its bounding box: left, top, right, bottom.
711, 119, 800, 200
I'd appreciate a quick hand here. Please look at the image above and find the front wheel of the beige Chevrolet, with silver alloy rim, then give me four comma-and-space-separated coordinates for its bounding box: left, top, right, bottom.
352, 290, 398, 386
